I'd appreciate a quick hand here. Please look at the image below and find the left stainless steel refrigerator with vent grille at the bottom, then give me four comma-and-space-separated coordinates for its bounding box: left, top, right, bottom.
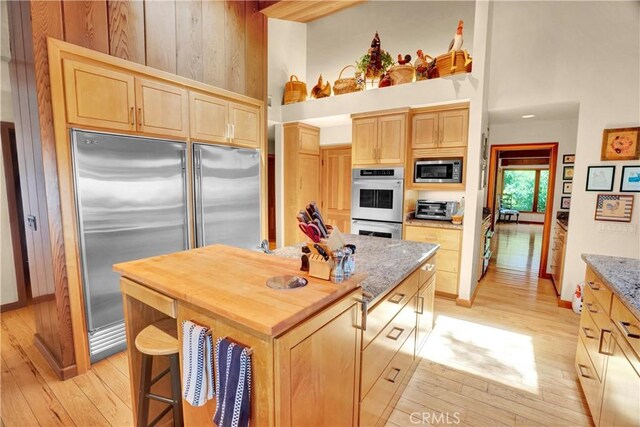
72, 130, 189, 362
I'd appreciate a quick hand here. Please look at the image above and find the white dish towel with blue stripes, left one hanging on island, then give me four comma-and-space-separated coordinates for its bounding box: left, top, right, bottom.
182, 320, 214, 406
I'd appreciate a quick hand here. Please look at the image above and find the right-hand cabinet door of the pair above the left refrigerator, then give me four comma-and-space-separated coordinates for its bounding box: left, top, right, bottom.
136, 78, 189, 137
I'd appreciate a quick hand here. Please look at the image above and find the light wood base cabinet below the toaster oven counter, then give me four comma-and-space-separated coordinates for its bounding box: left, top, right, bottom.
404, 225, 462, 297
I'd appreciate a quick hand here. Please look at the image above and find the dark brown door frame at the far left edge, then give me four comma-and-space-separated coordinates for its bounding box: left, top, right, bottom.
0, 122, 31, 311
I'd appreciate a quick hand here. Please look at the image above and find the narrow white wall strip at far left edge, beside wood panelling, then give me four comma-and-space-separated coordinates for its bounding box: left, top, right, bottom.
0, 1, 18, 304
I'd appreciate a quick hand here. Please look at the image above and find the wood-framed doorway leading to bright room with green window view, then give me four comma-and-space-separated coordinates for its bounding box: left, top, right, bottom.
487, 142, 558, 278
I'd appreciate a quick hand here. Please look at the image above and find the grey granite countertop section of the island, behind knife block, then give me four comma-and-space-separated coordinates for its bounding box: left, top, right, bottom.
273, 234, 440, 307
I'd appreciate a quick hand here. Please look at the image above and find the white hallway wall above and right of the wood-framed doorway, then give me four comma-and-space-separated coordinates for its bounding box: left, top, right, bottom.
489, 117, 578, 270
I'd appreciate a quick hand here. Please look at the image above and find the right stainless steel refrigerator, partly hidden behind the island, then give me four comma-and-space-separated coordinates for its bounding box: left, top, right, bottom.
193, 144, 260, 250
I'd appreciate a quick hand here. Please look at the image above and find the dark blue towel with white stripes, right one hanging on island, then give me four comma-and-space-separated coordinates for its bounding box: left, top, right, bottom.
213, 338, 251, 427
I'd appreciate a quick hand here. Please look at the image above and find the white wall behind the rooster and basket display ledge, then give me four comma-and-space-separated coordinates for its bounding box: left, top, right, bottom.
307, 1, 475, 83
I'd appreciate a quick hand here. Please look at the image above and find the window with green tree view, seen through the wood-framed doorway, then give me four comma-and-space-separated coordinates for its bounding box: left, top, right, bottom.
502, 169, 549, 213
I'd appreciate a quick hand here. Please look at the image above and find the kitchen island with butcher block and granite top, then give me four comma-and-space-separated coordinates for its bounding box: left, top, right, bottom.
114, 236, 437, 425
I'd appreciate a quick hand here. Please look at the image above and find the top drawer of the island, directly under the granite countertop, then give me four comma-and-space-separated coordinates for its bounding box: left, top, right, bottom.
362, 271, 419, 348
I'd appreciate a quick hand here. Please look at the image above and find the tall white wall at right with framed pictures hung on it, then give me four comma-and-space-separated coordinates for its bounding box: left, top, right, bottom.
489, 1, 640, 300
